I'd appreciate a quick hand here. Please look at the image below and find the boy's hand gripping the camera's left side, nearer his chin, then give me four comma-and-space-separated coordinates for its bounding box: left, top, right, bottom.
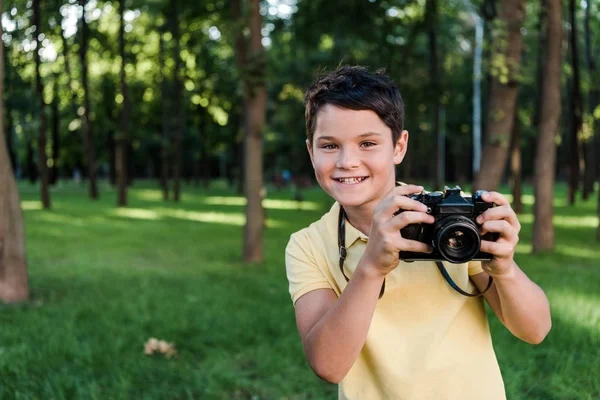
360, 185, 435, 276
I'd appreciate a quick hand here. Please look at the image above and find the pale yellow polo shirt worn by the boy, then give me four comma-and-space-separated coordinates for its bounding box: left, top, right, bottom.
286, 202, 506, 400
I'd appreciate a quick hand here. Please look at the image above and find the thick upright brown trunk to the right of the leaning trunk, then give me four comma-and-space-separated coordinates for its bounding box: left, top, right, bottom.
533, 0, 562, 252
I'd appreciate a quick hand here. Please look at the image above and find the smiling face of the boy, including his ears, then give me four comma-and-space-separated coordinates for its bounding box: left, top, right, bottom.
306, 104, 408, 211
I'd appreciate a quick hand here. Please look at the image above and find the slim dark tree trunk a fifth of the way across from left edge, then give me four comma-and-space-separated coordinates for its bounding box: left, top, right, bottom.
115, 0, 129, 207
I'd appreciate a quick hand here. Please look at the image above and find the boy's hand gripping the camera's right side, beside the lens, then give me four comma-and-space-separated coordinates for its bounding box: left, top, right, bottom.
476, 192, 521, 276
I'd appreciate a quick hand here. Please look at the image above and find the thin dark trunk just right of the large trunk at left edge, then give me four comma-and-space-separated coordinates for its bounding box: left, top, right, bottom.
33, 0, 50, 209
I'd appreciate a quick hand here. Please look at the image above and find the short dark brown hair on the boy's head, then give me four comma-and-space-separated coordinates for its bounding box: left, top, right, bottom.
304, 66, 404, 143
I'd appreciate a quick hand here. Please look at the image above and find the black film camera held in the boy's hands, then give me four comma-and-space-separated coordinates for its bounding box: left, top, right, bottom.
397, 186, 498, 264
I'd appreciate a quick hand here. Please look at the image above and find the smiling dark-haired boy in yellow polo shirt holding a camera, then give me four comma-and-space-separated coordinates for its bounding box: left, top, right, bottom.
286, 67, 551, 400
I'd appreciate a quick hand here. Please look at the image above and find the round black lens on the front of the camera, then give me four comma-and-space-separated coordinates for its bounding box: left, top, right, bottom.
434, 216, 481, 264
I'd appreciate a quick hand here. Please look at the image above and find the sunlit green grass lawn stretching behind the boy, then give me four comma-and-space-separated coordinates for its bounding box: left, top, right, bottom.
0, 183, 600, 400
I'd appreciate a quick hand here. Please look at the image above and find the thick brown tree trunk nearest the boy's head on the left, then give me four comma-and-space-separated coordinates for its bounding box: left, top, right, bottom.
233, 0, 267, 263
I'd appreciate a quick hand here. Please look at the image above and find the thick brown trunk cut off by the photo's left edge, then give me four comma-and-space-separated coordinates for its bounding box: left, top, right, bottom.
0, 4, 29, 303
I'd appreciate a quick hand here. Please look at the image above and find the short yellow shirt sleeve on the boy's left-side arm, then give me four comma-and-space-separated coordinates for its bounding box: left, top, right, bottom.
285, 231, 332, 304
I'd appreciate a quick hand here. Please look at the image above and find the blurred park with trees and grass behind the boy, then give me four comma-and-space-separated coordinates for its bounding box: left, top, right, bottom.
0, 0, 600, 399
